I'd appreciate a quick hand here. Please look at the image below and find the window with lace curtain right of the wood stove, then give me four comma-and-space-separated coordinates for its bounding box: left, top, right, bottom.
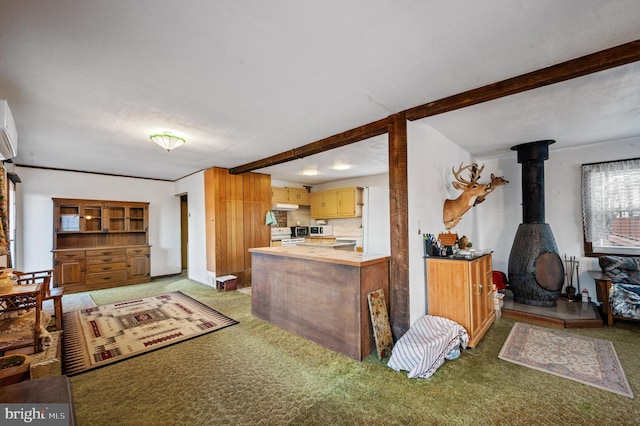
582, 158, 640, 256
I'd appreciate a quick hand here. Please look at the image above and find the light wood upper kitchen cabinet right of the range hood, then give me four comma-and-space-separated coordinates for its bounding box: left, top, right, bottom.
311, 186, 363, 219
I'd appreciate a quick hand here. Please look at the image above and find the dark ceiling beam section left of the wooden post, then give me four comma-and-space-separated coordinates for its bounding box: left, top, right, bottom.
229, 117, 389, 174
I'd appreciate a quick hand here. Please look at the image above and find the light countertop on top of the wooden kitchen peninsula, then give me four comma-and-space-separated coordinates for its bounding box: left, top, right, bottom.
249, 245, 389, 266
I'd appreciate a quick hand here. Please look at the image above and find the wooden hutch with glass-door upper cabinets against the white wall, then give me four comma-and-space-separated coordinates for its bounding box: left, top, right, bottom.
52, 198, 151, 293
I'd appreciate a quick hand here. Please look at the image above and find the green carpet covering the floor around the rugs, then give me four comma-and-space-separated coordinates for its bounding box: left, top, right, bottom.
71, 280, 640, 425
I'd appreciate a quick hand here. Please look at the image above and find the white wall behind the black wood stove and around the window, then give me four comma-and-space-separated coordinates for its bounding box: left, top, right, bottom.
474, 138, 640, 302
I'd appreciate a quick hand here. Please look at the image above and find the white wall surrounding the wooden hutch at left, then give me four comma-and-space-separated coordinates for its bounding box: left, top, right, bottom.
15, 167, 181, 277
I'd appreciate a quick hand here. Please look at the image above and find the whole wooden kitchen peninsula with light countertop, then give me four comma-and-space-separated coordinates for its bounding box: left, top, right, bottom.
249, 246, 389, 361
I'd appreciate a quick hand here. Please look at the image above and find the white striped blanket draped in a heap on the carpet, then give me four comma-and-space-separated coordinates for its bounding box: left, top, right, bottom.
387, 315, 469, 378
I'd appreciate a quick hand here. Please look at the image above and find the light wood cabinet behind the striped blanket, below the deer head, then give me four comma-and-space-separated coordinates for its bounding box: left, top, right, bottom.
426, 254, 496, 347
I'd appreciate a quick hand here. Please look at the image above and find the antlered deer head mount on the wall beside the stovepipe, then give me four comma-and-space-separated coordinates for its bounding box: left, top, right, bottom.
442, 163, 509, 229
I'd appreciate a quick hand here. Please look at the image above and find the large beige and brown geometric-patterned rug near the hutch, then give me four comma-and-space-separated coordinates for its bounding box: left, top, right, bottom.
64, 291, 238, 376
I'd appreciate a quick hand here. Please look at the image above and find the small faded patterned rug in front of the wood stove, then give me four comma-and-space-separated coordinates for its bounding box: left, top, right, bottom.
498, 322, 633, 398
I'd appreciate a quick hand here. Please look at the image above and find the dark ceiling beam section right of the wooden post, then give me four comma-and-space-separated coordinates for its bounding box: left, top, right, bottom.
405, 40, 640, 121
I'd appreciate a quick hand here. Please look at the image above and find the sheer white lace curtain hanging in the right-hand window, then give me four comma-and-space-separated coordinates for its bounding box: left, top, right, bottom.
582, 158, 640, 246
